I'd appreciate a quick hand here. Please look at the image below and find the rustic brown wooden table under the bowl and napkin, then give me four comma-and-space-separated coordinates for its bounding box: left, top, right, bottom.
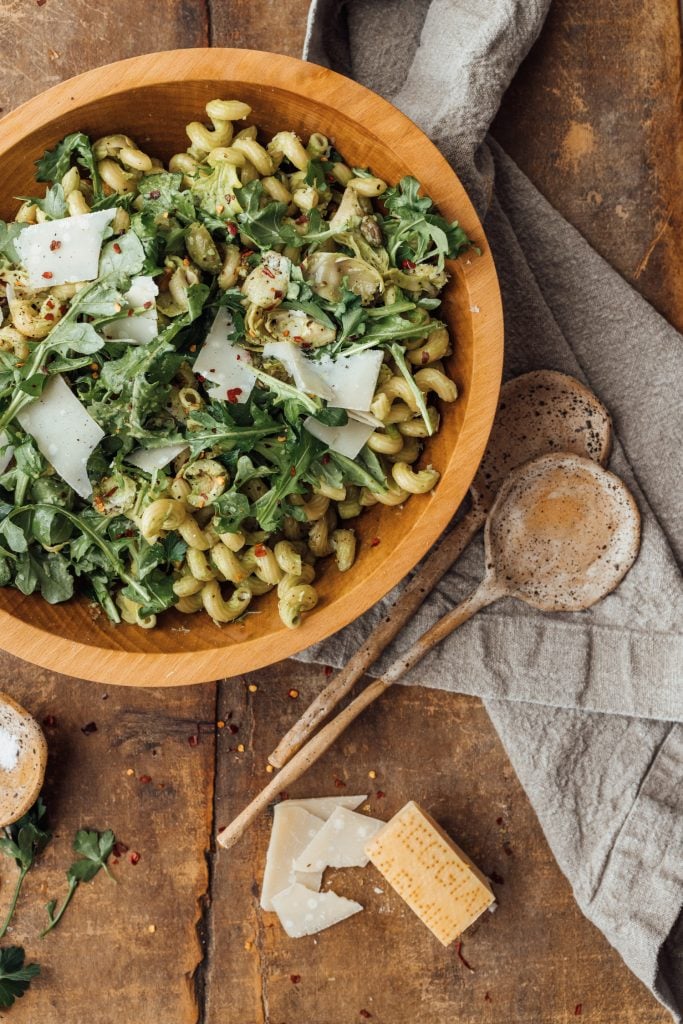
0, 0, 683, 1024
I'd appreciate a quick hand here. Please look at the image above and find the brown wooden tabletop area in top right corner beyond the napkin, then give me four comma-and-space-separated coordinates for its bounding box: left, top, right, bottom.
494, 0, 683, 329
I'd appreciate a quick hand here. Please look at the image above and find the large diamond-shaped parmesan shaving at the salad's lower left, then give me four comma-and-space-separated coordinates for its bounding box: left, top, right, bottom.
16, 374, 104, 498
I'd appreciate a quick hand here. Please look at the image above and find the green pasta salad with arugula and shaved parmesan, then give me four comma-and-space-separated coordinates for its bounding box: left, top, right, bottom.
0, 99, 469, 629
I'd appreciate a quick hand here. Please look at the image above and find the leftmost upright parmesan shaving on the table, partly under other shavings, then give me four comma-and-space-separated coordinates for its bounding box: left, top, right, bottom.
261, 801, 324, 910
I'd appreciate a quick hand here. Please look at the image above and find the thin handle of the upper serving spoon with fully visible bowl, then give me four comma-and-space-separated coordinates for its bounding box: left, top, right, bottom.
218, 577, 502, 849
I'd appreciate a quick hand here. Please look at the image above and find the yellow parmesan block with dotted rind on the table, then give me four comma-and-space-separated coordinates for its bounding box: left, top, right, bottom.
366, 801, 496, 946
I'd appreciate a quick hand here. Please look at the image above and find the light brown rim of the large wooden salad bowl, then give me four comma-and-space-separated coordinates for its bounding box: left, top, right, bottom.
0, 47, 503, 686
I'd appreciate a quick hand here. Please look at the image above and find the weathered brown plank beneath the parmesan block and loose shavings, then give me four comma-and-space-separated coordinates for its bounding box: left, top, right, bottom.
206, 663, 667, 1024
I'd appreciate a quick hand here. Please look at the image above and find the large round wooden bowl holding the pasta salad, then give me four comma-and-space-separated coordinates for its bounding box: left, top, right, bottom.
0, 49, 503, 686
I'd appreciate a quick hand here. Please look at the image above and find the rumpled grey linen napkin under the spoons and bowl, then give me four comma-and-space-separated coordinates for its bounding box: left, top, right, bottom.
302, 0, 683, 1022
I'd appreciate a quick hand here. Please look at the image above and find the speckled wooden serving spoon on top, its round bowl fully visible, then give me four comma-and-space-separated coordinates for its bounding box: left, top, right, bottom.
218, 453, 640, 847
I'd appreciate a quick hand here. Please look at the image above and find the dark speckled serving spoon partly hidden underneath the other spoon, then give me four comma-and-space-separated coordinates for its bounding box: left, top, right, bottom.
268, 370, 611, 768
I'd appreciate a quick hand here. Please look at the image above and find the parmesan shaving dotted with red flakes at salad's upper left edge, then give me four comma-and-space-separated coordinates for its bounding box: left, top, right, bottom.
14, 209, 116, 290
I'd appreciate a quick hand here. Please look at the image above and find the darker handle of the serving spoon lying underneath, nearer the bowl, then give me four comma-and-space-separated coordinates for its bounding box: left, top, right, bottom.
268, 506, 485, 768
